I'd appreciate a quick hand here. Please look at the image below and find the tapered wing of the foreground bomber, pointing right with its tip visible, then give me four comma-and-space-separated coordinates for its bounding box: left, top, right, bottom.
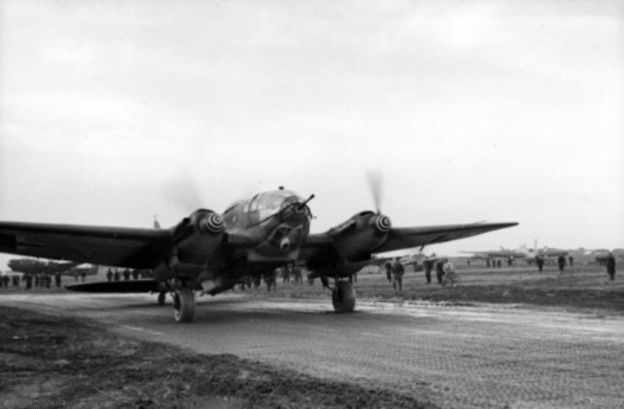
375, 223, 518, 253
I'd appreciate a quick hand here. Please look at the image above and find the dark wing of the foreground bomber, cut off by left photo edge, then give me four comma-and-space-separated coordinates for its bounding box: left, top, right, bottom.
0, 222, 172, 268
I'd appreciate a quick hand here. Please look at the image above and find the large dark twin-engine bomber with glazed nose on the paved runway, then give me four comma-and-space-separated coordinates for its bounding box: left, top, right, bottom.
0, 188, 517, 322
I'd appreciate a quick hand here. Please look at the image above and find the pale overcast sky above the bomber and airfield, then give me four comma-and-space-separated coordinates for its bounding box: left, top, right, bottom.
0, 0, 624, 266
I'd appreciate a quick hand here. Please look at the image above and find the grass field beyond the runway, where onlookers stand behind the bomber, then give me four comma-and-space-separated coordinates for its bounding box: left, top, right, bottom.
264, 264, 624, 312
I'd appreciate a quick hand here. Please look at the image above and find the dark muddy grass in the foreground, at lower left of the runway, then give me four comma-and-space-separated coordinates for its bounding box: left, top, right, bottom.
0, 307, 436, 409
